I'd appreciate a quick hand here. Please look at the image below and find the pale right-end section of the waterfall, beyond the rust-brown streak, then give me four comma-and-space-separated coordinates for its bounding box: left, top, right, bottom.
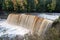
38, 19, 53, 35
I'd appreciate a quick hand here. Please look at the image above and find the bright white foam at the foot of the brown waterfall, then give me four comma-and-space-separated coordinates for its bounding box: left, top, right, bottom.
0, 22, 30, 36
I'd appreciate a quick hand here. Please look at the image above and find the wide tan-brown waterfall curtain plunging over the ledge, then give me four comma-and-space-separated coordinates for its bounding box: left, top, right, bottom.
7, 14, 53, 35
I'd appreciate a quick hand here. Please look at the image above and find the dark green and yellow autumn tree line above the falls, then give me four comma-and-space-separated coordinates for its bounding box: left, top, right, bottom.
0, 0, 60, 12
